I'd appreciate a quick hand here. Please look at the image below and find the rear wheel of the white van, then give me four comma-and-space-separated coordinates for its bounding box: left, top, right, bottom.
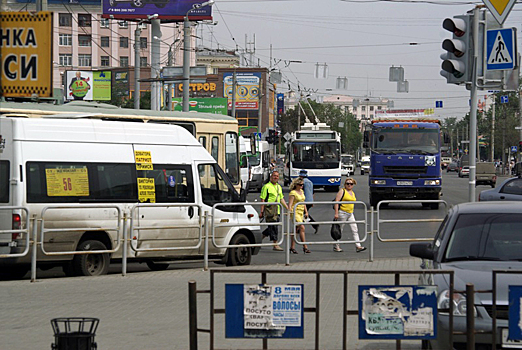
72, 241, 110, 276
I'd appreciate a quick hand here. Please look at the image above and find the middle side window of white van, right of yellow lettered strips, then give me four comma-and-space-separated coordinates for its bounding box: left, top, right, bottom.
138, 164, 195, 203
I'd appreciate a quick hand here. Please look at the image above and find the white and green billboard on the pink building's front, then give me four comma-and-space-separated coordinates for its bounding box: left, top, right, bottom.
65, 70, 111, 101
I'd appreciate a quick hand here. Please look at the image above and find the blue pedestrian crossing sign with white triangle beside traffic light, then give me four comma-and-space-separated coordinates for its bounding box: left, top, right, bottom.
486, 28, 517, 70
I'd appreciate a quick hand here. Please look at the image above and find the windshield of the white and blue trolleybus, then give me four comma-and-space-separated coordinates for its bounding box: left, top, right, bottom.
292, 142, 341, 169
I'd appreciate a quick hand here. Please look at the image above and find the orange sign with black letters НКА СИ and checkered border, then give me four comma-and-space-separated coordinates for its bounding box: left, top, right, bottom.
0, 12, 53, 97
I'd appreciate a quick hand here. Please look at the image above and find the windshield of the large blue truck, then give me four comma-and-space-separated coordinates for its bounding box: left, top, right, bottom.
372, 128, 439, 153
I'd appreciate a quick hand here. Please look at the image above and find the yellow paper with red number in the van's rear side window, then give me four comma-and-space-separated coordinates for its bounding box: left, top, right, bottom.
45, 168, 89, 197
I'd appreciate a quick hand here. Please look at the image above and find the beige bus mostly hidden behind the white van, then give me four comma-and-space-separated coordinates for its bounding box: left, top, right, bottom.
0, 101, 241, 192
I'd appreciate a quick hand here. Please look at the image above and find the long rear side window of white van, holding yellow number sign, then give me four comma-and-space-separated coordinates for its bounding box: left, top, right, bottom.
26, 162, 137, 203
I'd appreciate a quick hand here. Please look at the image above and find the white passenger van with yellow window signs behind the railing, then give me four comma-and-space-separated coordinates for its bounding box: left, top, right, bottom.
0, 117, 261, 277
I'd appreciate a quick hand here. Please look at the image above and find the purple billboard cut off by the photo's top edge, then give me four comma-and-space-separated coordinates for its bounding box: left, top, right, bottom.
102, 0, 212, 22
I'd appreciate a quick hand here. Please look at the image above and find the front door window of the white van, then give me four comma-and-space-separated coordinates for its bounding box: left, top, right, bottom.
198, 164, 239, 209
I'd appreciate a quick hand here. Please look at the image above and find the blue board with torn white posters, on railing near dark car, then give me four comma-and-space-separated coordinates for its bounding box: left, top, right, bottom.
359, 286, 437, 339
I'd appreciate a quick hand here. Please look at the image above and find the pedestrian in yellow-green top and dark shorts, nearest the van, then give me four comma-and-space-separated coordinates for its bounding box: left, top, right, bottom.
259, 171, 288, 251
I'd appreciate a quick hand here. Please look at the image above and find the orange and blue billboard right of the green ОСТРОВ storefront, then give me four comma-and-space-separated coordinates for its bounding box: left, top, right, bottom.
223, 72, 261, 110
